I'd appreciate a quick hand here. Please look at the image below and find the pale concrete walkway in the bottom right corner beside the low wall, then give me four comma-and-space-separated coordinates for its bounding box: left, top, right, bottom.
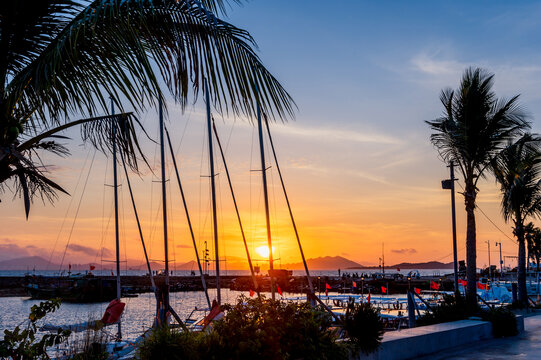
419, 315, 541, 360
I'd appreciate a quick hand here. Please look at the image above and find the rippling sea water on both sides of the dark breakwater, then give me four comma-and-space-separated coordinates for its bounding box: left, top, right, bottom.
0, 269, 451, 340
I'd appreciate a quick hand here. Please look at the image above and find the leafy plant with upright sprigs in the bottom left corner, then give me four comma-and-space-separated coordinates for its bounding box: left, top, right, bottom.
0, 299, 70, 360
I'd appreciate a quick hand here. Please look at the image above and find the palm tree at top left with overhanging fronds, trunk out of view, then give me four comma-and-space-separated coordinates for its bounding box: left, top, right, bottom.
0, 0, 294, 217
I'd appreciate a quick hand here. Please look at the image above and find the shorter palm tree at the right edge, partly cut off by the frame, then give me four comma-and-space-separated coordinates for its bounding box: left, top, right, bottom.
492, 134, 541, 305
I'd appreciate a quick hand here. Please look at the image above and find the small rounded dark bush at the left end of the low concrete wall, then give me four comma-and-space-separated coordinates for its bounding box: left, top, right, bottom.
343, 300, 383, 354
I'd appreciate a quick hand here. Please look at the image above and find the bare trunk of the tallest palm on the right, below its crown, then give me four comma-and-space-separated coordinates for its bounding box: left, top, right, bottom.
464, 184, 477, 305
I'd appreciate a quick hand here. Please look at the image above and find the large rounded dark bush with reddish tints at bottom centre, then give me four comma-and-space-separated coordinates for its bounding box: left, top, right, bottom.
209, 296, 347, 360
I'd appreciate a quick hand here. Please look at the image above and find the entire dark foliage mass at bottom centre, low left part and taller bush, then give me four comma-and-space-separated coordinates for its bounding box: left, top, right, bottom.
138, 296, 348, 360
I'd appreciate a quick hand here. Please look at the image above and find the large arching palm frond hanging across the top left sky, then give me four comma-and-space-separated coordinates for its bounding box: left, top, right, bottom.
6, 0, 294, 129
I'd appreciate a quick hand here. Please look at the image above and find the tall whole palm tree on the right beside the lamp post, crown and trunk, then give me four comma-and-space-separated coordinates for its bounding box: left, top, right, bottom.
427, 68, 529, 304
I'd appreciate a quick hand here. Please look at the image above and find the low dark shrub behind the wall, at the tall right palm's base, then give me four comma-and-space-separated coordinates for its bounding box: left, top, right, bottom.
417, 294, 479, 326
